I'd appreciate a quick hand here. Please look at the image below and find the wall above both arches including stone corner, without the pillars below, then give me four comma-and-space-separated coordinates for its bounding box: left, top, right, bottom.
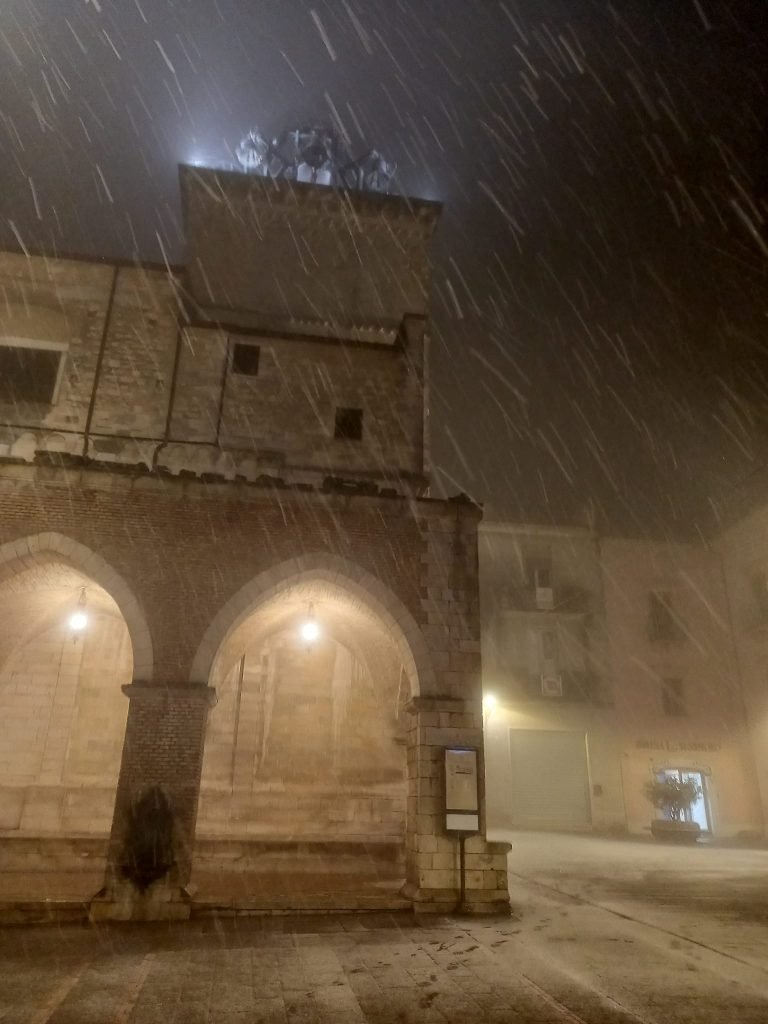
0, 465, 487, 694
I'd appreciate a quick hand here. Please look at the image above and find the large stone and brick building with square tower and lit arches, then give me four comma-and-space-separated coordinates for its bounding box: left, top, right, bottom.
0, 167, 508, 918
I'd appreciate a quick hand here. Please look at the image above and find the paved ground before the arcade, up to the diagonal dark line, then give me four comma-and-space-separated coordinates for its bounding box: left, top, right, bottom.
0, 885, 768, 1024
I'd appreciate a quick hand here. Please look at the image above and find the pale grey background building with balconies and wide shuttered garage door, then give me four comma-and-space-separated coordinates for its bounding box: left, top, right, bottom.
479, 523, 624, 829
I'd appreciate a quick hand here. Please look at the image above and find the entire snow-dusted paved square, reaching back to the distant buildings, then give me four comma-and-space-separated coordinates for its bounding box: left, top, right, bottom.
0, 835, 768, 1024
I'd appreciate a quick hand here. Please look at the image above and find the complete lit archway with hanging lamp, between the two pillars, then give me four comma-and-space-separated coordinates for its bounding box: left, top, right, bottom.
193, 555, 431, 901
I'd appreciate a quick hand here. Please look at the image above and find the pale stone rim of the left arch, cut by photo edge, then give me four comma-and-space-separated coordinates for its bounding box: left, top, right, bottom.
0, 532, 154, 682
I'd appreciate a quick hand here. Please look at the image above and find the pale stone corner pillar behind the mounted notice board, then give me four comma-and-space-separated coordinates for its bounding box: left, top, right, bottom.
402, 696, 510, 913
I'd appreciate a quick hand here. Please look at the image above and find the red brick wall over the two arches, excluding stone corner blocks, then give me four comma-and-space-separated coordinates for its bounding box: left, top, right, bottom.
0, 466, 429, 682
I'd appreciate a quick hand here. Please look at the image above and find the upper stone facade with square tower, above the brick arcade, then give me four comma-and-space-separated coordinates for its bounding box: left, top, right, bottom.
0, 171, 438, 490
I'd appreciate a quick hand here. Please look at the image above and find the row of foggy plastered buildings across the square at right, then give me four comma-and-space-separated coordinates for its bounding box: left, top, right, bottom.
480, 522, 768, 839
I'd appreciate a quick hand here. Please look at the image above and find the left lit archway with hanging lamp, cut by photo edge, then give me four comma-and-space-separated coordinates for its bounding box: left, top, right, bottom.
0, 534, 152, 836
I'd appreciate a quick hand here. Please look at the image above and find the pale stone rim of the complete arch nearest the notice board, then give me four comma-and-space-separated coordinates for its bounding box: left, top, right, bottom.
189, 553, 434, 696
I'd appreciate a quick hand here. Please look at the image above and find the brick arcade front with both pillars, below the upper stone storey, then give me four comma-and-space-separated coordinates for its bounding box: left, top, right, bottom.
0, 464, 507, 916
